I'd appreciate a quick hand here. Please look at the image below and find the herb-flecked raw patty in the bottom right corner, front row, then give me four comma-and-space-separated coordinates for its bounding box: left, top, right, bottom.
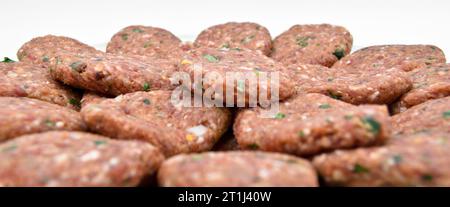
313, 133, 450, 186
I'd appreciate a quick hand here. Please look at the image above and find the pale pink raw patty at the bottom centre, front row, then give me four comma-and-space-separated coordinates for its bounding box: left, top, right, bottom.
158, 152, 318, 187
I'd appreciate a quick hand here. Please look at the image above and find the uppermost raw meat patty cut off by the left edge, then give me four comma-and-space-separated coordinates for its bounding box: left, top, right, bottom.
0, 62, 81, 110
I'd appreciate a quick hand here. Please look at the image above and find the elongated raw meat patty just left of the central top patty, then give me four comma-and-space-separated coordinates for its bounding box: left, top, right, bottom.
49, 52, 177, 96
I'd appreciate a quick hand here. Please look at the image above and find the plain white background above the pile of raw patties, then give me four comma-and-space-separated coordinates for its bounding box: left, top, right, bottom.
0, 0, 450, 59
